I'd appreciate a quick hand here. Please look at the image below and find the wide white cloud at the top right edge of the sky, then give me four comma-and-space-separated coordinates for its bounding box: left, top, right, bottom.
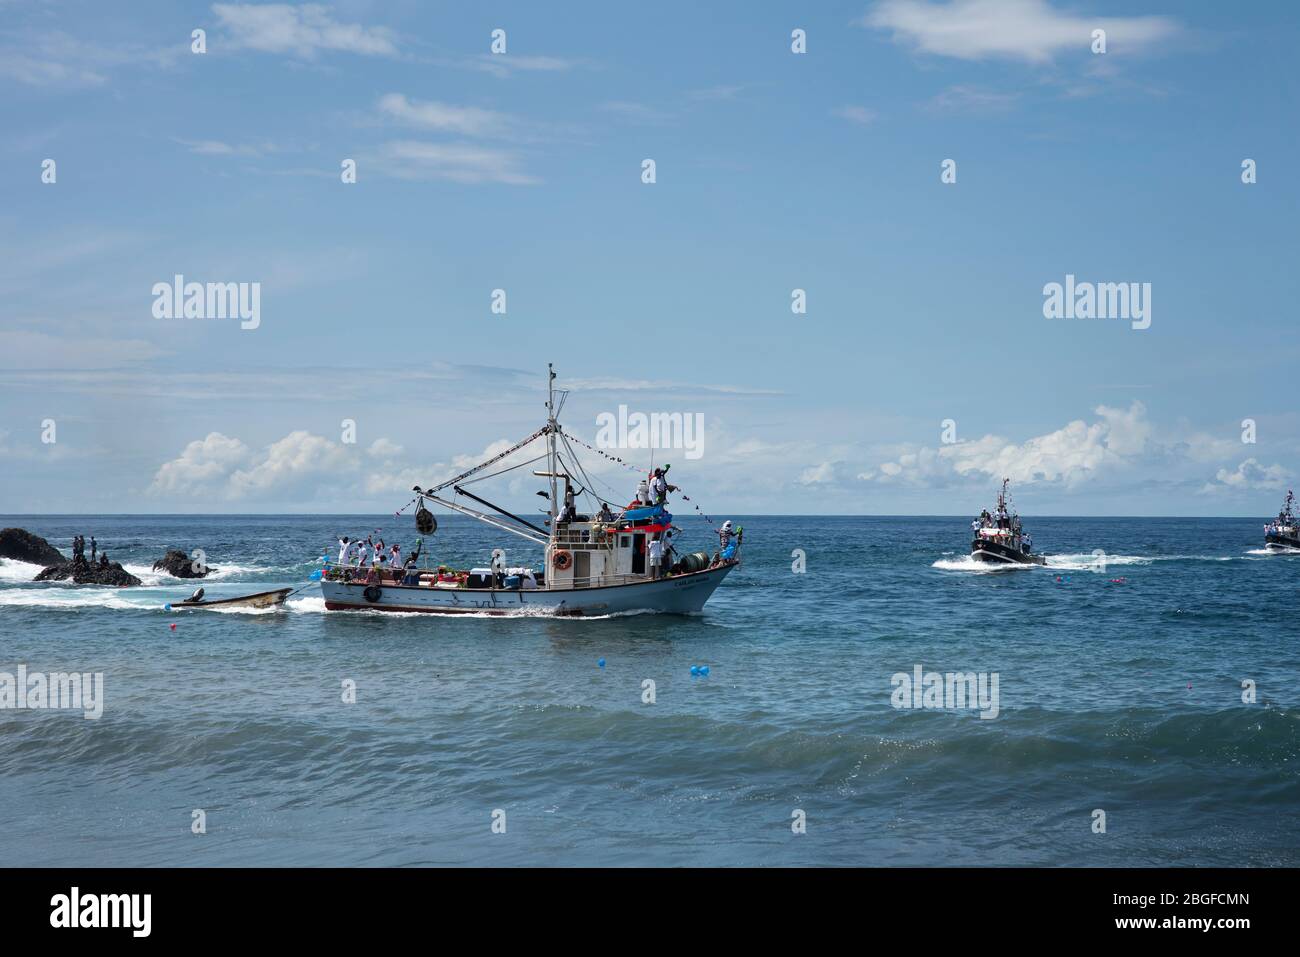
861, 0, 1180, 64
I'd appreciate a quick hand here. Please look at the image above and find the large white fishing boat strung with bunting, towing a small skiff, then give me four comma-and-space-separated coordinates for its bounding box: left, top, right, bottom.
320, 365, 744, 616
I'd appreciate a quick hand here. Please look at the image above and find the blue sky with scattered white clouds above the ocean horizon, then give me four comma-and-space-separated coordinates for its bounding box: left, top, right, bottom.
0, 0, 1300, 516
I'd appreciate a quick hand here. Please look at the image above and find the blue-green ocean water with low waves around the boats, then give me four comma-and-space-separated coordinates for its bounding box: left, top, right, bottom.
0, 516, 1300, 866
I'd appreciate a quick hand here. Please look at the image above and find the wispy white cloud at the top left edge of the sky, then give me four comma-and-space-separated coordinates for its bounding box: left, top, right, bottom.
212, 4, 398, 60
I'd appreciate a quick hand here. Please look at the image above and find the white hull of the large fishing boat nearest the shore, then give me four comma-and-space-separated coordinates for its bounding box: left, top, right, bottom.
321, 562, 738, 615
